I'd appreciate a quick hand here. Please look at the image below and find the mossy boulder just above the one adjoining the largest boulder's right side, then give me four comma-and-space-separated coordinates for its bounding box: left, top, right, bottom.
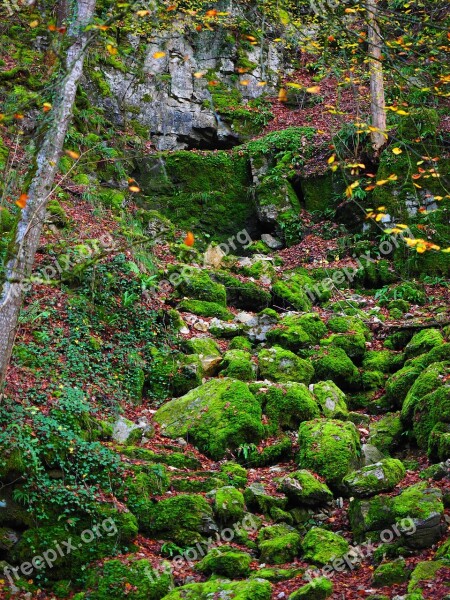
258, 346, 314, 385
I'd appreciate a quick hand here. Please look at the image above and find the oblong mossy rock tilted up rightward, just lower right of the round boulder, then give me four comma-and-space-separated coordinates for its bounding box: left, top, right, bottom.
343, 458, 406, 498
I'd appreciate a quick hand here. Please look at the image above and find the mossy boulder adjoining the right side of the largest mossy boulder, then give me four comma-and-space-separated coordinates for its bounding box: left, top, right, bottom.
257, 383, 320, 435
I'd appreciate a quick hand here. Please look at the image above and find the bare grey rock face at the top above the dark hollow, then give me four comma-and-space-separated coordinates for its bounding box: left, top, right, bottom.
90, 0, 282, 150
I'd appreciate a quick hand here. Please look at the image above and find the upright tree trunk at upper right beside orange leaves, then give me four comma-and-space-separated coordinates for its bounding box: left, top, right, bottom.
366, 0, 386, 155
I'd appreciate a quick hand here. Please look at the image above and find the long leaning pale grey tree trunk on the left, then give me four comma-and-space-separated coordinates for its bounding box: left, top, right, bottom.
0, 0, 95, 390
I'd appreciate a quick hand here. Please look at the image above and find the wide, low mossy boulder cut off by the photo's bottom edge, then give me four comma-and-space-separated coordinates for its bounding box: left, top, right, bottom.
162, 579, 272, 600
